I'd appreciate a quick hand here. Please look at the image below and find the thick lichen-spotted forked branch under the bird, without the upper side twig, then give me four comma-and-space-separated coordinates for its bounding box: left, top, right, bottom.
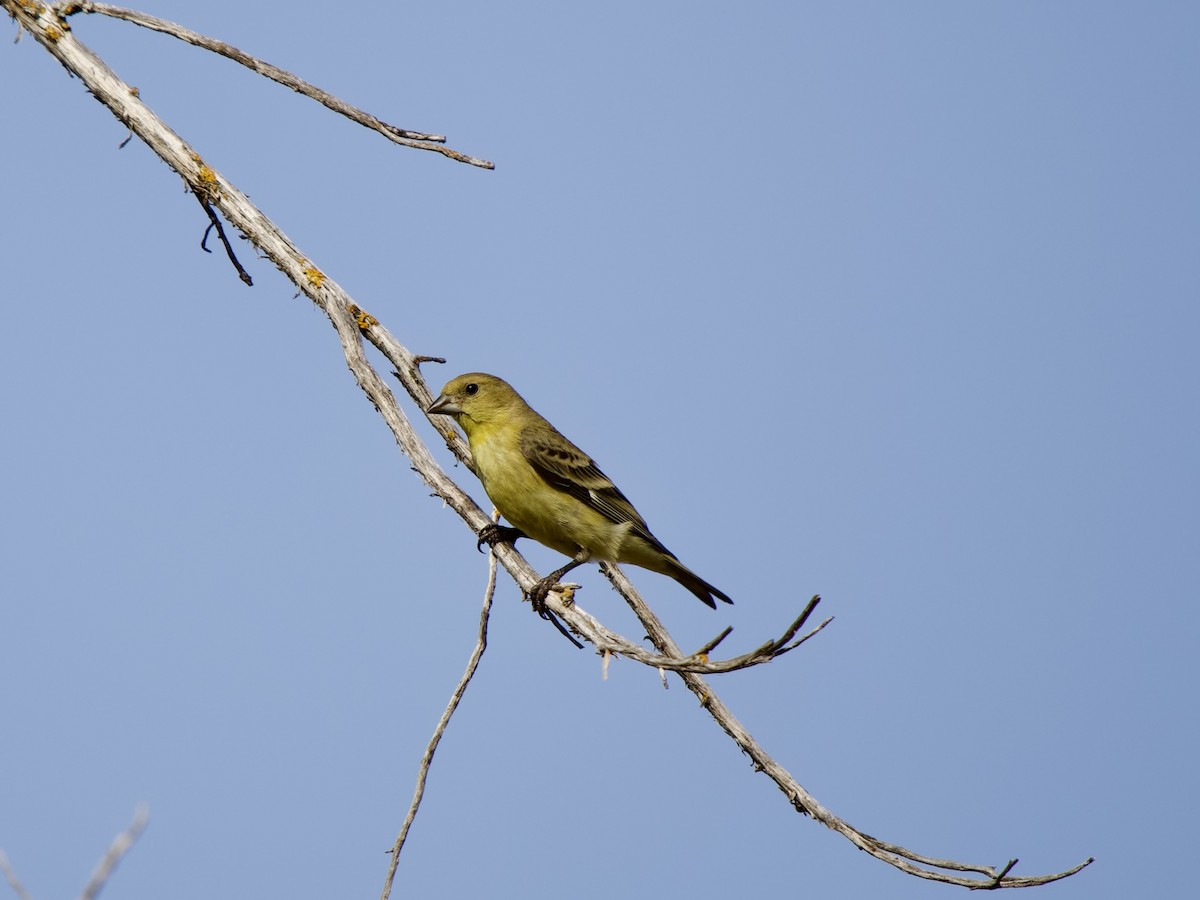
0, 0, 1092, 889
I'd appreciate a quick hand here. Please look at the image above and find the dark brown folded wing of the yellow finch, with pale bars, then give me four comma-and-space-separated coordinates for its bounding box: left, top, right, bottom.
521, 422, 674, 557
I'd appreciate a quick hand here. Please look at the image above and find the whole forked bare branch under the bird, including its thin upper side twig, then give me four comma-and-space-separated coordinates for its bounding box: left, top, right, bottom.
0, 0, 1093, 889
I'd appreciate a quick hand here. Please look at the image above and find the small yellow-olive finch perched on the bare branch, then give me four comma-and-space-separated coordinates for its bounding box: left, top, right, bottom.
427, 372, 733, 610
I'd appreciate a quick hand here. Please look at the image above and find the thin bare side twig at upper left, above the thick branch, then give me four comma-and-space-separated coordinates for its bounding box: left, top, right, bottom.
55, 1, 496, 169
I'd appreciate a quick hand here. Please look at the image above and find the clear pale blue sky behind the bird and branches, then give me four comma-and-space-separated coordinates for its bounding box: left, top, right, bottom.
0, 0, 1200, 900
